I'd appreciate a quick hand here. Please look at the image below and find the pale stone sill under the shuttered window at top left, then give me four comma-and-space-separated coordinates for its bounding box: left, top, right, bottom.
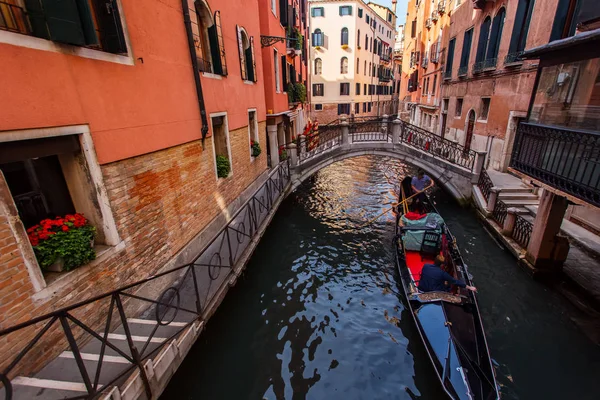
0, 30, 135, 65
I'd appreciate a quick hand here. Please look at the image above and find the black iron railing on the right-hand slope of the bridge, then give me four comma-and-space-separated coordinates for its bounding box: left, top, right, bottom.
400, 122, 475, 170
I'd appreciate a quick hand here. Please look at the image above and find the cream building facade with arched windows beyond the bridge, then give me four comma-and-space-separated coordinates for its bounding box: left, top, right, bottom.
309, 0, 396, 123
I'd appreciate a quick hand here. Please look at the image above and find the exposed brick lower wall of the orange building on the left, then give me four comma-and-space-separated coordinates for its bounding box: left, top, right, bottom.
0, 121, 267, 376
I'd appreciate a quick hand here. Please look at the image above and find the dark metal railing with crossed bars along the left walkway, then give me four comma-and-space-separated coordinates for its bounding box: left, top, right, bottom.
0, 162, 290, 400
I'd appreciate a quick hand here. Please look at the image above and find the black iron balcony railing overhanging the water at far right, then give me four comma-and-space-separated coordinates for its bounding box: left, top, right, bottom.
510, 122, 600, 207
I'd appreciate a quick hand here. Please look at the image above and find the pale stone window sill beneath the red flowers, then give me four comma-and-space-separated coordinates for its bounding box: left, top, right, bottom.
32, 241, 125, 301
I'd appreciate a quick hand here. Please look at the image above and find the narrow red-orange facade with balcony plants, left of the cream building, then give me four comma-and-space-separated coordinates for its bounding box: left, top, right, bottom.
258, 0, 309, 164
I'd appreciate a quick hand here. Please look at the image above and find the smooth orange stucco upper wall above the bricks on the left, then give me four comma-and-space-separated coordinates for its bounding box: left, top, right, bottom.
0, 0, 266, 164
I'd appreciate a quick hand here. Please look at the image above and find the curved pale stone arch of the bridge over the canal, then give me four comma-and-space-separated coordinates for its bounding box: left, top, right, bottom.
291, 143, 472, 204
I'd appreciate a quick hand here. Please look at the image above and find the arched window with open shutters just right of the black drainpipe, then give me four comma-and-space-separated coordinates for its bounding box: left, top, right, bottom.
192, 0, 227, 75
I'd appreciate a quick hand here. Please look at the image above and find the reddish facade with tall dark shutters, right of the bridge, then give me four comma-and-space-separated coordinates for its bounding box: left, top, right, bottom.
440, 0, 559, 172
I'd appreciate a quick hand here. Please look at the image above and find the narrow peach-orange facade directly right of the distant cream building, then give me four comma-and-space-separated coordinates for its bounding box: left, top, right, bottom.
400, 0, 452, 132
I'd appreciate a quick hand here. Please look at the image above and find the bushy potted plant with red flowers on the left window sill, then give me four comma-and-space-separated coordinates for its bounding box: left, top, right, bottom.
27, 214, 96, 272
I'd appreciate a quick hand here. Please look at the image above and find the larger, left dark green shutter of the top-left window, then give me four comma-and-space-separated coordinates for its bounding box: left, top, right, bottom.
42, 0, 86, 46
